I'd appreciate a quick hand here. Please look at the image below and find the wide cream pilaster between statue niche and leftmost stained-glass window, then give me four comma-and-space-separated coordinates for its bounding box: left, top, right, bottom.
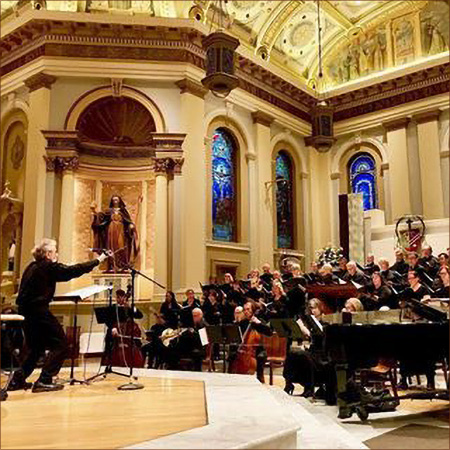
174, 79, 207, 291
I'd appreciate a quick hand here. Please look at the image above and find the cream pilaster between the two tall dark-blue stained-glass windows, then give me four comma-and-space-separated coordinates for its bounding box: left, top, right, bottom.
252, 111, 277, 268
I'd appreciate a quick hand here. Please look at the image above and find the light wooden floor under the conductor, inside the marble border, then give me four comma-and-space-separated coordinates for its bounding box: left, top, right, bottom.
1, 375, 207, 449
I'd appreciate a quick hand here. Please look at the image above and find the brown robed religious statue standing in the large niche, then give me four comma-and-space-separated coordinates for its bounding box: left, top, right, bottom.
91, 195, 142, 272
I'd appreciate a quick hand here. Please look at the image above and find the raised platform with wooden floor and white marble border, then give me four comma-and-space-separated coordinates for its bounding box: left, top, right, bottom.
1, 369, 300, 449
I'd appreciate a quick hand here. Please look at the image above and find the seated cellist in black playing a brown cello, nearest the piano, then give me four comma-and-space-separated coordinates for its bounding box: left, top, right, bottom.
229, 301, 272, 383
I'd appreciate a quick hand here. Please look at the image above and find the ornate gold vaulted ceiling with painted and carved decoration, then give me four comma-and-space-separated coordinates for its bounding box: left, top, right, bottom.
0, 0, 449, 91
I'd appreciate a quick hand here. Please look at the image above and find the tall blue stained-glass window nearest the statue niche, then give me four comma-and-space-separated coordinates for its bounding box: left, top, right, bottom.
212, 128, 237, 242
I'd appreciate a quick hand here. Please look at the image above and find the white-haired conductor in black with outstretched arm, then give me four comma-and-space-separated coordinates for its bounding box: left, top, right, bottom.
10, 239, 107, 392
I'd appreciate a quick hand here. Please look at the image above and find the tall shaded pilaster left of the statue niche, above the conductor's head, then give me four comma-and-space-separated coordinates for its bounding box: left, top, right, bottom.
20, 73, 56, 271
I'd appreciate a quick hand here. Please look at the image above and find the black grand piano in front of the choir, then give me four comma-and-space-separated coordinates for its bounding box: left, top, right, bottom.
324, 300, 449, 420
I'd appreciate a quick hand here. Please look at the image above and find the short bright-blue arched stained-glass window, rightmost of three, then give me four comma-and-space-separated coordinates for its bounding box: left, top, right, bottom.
349, 153, 378, 211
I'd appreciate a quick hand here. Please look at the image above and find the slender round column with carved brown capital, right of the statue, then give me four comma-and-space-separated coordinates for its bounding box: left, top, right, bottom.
153, 158, 170, 298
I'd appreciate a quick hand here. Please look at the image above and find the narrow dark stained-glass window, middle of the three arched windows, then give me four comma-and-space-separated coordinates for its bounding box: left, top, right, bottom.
275, 151, 294, 248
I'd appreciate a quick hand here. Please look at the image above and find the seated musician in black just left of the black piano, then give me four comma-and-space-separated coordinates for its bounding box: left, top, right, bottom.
283, 298, 336, 405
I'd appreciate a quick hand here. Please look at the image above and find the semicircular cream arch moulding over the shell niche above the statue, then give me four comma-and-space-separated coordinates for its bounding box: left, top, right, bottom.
64, 85, 166, 133
